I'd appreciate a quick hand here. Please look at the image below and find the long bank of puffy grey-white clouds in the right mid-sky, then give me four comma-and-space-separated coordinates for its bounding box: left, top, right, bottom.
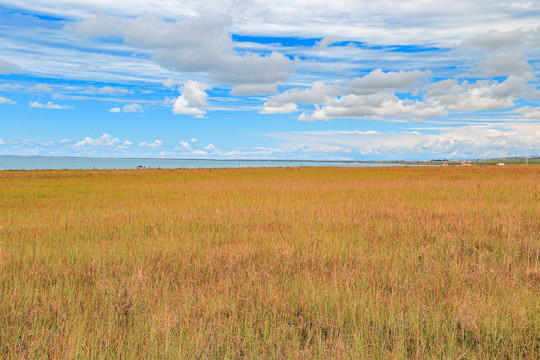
261, 52, 536, 121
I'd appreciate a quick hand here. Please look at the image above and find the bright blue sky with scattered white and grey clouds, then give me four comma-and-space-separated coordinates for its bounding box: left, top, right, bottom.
0, 0, 540, 160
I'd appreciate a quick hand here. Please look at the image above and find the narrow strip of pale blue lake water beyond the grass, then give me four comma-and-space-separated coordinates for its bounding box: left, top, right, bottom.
0, 155, 400, 170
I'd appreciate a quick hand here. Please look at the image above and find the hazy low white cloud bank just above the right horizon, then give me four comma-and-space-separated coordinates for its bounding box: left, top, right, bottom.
269, 123, 540, 159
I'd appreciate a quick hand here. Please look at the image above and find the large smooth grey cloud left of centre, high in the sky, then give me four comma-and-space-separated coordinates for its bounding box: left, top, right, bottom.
66, 11, 293, 91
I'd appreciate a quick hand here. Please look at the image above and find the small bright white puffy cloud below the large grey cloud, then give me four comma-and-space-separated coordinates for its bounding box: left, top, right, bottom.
172, 80, 211, 117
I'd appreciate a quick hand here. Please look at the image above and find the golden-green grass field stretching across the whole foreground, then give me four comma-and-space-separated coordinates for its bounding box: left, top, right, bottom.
0, 165, 540, 359
